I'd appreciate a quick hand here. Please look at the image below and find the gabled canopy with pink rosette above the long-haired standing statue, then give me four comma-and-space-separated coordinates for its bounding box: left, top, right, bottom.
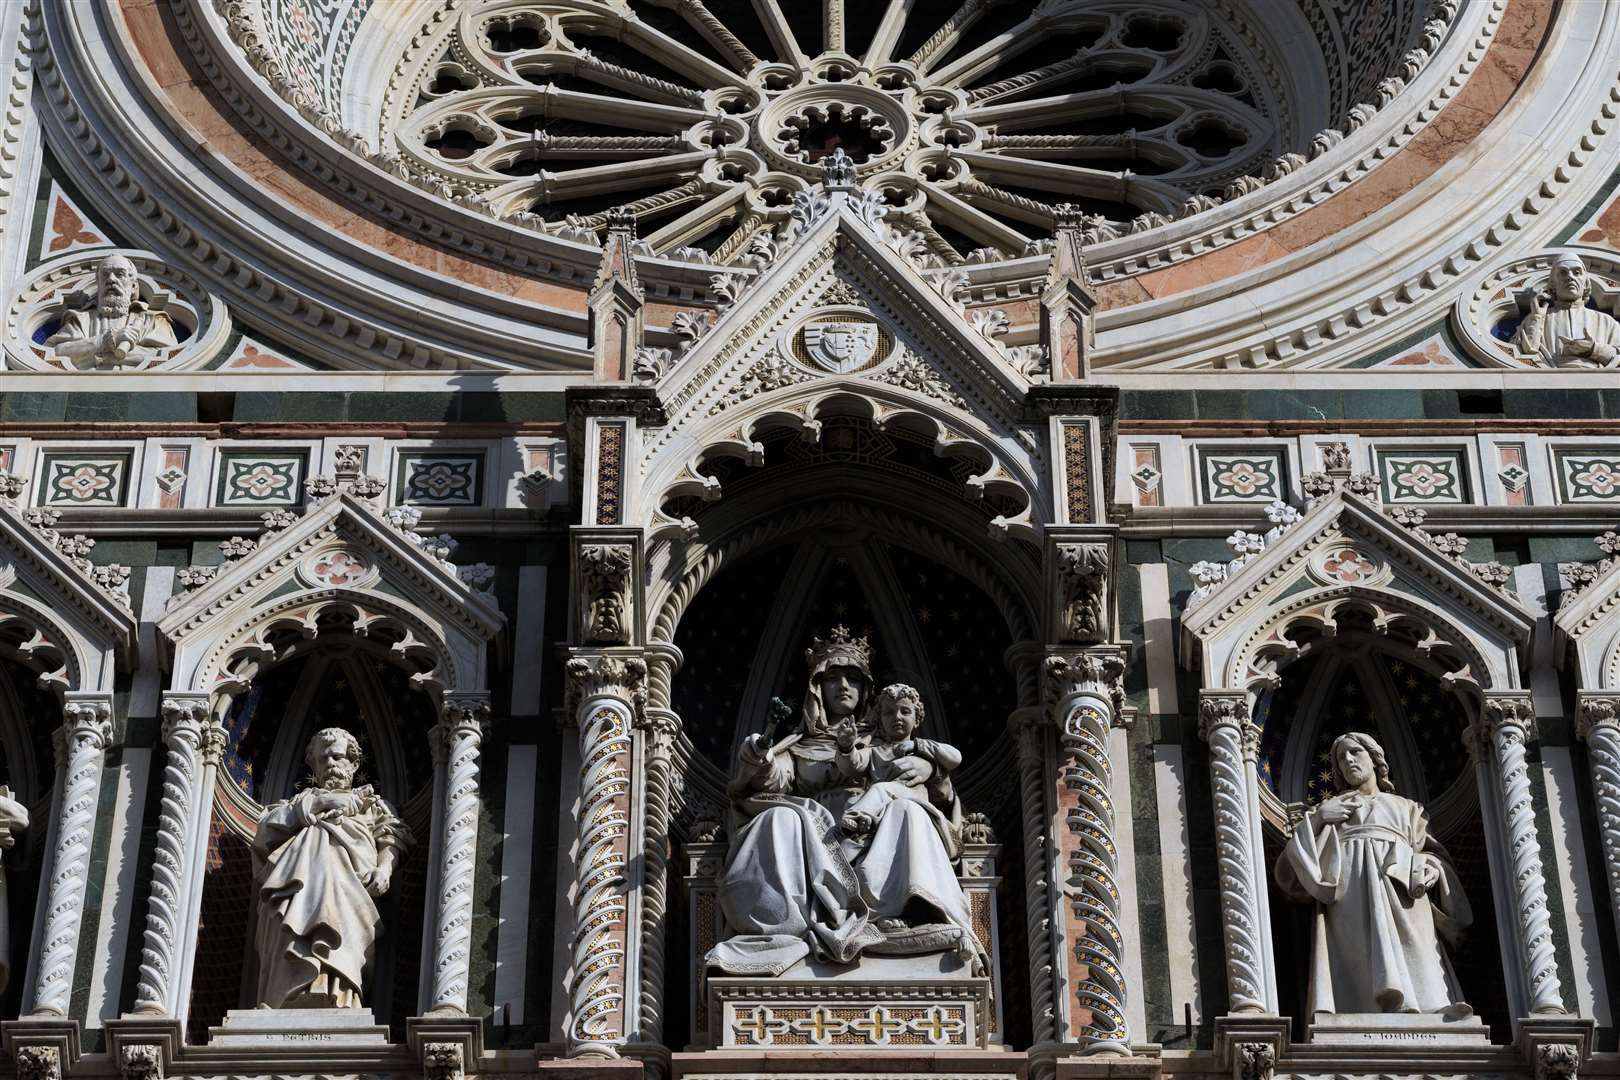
1181, 492, 1536, 690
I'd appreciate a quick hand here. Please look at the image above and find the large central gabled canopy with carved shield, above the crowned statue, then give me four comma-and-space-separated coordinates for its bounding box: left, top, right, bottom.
640, 186, 1050, 537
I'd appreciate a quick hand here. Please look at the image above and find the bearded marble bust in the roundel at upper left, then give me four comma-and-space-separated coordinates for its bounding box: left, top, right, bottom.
45, 254, 178, 369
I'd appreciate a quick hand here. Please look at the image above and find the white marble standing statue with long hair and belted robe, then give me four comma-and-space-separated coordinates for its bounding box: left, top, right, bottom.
1277, 732, 1474, 1020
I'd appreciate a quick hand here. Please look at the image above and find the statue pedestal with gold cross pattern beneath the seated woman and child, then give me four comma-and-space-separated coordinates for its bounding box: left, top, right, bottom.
706, 952, 993, 1052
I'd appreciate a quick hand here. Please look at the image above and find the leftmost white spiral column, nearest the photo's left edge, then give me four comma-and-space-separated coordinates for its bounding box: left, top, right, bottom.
31, 693, 112, 1017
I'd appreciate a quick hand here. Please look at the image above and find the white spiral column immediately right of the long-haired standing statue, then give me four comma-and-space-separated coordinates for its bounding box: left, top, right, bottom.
1469, 691, 1565, 1015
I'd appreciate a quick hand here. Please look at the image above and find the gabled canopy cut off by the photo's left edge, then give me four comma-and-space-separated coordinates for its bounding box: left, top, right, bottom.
0, 507, 139, 693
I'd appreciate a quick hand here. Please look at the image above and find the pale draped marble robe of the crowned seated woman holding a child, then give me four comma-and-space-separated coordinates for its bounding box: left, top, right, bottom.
706, 733, 983, 975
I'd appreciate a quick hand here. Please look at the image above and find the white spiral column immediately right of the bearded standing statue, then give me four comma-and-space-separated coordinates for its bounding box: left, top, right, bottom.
428, 693, 489, 1015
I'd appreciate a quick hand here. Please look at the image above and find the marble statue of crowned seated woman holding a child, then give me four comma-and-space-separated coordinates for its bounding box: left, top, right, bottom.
706, 627, 985, 975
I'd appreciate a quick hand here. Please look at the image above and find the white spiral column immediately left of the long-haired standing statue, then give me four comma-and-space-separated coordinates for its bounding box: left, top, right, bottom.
1199, 690, 1277, 1014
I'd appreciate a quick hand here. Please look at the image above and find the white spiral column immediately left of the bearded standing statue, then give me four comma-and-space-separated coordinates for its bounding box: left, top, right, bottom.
134, 693, 222, 1017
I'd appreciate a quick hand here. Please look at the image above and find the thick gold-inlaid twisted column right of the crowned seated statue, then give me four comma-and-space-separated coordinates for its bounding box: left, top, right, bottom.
1047, 648, 1131, 1054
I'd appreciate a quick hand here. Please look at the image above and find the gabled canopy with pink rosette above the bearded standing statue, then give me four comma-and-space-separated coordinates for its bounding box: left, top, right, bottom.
157, 492, 505, 693
